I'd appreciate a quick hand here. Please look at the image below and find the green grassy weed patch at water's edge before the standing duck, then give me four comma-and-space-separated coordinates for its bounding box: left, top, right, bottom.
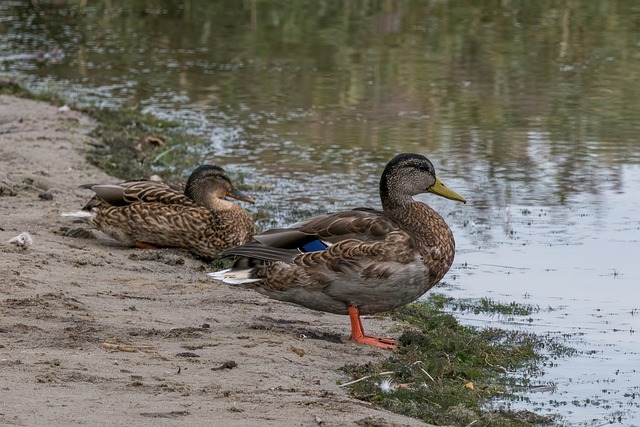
342, 294, 573, 427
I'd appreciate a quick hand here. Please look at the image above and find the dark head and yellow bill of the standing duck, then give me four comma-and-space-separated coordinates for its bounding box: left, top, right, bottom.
380, 153, 467, 206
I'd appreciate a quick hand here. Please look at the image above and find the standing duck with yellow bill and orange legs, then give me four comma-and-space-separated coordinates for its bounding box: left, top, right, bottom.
208, 153, 466, 349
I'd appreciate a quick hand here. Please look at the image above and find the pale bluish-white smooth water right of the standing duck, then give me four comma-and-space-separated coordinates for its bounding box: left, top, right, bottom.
448, 166, 640, 425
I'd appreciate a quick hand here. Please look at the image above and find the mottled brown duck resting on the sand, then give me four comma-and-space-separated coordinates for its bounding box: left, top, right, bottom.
62, 165, 255, 260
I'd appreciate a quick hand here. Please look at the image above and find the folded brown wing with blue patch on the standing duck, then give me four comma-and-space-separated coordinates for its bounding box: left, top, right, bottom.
222, 208, 398, 267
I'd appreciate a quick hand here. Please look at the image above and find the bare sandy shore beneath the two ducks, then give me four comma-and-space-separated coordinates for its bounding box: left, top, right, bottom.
0, 96, 432, 426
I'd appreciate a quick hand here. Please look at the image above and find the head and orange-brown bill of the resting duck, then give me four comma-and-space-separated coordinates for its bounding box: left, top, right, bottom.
184, 165, 255, 206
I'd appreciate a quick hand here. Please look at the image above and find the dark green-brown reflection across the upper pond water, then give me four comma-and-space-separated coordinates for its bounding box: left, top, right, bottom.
0, 1, 640, 187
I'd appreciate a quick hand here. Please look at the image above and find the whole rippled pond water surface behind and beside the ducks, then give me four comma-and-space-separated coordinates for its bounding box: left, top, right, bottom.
0, 0, 640, 426
